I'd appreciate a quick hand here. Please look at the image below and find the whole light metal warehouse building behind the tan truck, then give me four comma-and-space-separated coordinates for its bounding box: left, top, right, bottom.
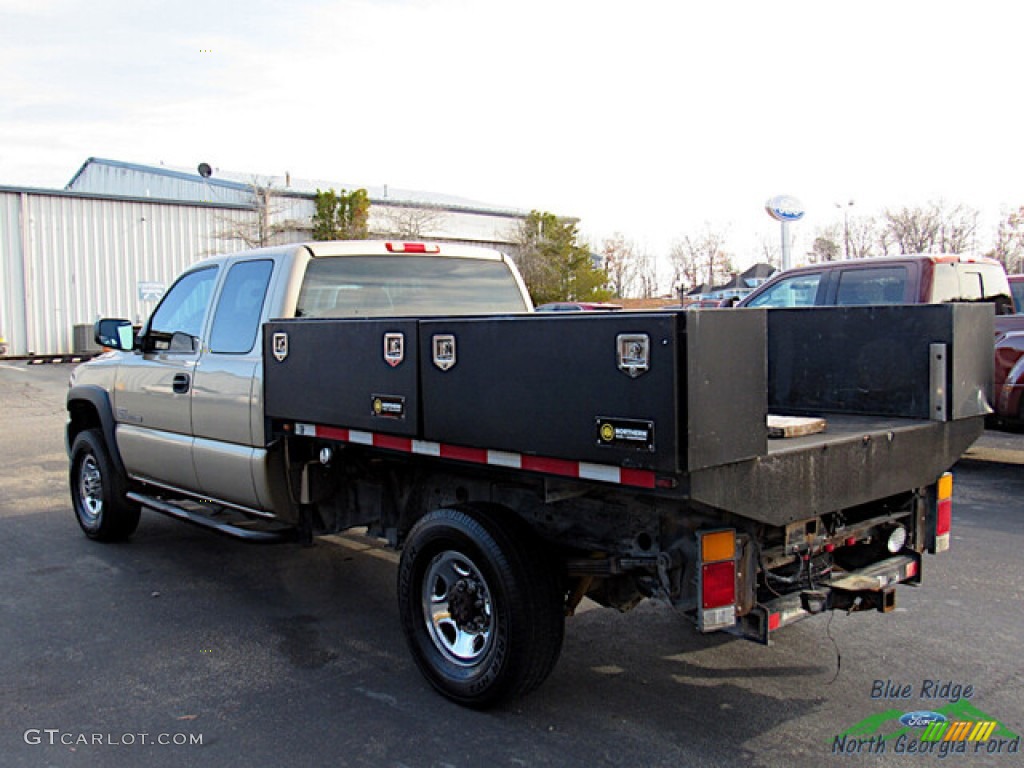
0, 158, 525, 355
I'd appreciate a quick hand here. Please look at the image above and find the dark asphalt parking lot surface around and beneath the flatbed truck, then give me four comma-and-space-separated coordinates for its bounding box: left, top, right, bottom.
0, 361, 1024, 768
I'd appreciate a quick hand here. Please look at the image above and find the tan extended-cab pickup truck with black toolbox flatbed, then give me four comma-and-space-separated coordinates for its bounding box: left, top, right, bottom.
67, 242, 992, 707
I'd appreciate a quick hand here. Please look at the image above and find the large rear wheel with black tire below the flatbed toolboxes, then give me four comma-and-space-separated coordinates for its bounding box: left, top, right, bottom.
398, 508, 565, 708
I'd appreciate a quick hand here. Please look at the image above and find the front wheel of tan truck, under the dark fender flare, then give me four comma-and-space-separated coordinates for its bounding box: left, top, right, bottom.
71, 429, 140, 542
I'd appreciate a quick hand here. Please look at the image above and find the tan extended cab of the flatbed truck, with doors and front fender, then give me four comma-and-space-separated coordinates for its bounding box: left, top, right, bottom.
68, 242, 532, 524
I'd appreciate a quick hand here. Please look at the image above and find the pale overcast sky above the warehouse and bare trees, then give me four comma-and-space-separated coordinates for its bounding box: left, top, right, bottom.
0, 0, 1024, 276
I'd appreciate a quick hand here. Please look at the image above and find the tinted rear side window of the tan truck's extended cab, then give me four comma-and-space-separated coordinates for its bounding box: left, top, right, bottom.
210, 259, 273, 354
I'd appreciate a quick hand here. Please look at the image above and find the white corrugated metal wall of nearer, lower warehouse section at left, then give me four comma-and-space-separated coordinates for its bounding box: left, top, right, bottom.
0, 190, 256, 354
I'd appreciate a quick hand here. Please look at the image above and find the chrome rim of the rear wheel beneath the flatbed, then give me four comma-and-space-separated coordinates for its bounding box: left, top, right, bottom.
422, 551, 495, 667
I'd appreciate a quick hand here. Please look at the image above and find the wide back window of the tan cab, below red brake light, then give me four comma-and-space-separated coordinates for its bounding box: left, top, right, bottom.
296, 256, 526, 317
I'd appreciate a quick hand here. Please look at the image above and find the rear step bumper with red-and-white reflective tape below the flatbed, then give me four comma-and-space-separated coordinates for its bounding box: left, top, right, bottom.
729, 552, 921, 645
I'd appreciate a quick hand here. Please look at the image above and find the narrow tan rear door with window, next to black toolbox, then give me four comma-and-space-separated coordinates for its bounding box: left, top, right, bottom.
193, 258, 274, 509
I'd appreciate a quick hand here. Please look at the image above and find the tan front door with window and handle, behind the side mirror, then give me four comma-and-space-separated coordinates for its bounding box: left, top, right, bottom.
114, 266, 218, 490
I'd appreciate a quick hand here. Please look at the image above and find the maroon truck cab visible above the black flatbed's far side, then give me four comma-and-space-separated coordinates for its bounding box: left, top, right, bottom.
737, 255, 1014, 314
